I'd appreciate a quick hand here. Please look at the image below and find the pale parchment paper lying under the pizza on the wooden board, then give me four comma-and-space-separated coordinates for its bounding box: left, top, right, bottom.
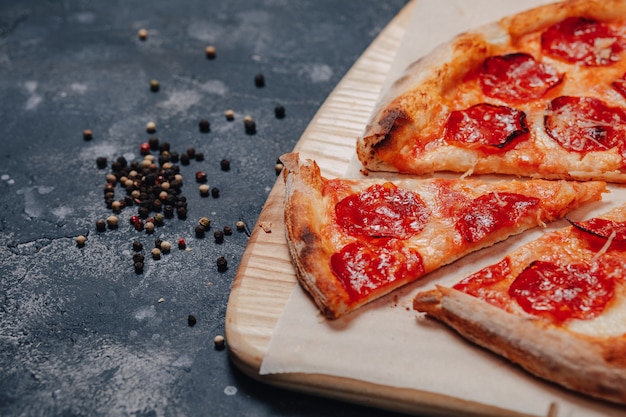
260, 0, 626, 417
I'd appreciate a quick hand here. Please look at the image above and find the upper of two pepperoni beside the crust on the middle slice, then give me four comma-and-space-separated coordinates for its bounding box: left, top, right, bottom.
335, 182, 430, 239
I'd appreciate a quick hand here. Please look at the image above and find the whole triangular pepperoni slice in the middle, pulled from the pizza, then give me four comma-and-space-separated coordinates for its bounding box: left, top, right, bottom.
281, 153, 606, 318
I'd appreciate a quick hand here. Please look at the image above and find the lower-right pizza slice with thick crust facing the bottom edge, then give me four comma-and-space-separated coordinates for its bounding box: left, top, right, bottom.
413, 205, 626, 404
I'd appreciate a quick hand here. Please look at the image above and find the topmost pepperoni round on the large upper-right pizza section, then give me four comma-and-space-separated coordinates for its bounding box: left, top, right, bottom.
541, 17, 623, 66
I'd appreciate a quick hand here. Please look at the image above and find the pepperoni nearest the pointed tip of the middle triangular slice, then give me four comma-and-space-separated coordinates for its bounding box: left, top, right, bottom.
455, 192, 541, 243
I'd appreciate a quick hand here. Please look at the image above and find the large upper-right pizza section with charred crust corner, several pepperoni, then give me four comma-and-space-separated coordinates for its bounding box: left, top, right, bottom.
356, 0, 626, 183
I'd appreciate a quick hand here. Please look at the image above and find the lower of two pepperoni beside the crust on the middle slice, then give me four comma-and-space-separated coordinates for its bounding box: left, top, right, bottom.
330, 238, 424, 300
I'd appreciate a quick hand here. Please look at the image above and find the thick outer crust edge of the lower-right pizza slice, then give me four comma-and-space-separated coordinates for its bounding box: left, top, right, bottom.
413, 287, 626, 404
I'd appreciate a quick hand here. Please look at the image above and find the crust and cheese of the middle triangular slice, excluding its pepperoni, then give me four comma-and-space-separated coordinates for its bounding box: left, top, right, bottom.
281, 153, 606, 318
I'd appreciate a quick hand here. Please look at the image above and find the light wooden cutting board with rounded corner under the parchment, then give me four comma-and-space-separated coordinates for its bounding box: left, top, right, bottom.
226, 0, 544, 417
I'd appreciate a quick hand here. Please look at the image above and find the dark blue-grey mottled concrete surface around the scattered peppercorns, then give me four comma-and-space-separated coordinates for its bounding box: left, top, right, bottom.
0, 0, 414, 417
